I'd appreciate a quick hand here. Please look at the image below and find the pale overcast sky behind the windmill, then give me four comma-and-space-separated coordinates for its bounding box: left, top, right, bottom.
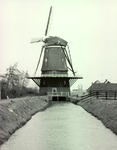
0, 0, 117, 89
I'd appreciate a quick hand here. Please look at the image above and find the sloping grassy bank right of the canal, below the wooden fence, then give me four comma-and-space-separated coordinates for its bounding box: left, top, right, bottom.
78, 97, 117, 135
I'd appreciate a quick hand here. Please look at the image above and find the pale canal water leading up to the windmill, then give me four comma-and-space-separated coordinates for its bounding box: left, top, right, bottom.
0, 102, 117, 150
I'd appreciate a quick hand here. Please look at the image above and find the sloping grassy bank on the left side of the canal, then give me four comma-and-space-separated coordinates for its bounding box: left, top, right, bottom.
0, 97, 50, 145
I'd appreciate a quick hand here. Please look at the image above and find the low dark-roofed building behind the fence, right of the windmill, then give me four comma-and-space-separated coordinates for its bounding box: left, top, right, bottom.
87, 80, 117, 99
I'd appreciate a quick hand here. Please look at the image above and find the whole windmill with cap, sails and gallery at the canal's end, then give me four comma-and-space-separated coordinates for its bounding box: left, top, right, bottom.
28, 6, 82, 100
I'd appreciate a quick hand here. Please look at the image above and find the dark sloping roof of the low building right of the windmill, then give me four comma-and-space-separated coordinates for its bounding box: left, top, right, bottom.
88, 82, 117, 91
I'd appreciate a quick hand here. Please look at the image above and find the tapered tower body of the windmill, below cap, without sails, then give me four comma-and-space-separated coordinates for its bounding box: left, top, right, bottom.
40, 42, 70, 95
